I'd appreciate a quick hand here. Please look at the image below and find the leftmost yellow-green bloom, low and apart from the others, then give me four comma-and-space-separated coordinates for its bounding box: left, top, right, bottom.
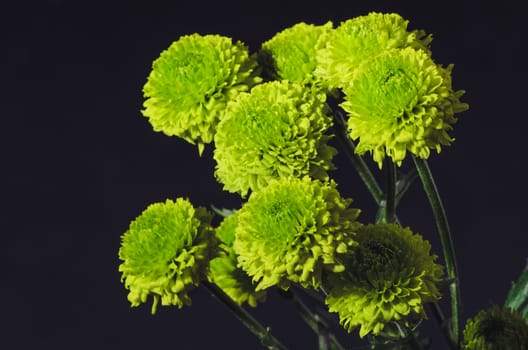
119, 198, 218, 314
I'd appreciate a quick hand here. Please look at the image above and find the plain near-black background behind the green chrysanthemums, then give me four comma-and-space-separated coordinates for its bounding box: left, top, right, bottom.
4, 0, 528, 350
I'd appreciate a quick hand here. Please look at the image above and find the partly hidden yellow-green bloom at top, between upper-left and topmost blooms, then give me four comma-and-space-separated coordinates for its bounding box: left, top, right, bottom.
261, 22, 333, 84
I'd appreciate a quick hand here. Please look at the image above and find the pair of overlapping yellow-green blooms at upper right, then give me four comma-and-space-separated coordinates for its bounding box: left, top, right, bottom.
315, 13, 468, 168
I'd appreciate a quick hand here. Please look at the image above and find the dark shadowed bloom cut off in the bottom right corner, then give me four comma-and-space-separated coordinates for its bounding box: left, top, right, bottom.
462, 305, 528, 350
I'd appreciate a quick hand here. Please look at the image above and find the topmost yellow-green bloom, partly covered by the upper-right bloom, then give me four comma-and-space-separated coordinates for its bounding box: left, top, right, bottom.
315, 12, 432, 88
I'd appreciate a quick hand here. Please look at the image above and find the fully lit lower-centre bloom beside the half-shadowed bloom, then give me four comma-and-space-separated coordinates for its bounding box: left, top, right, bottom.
233, 177, 360, 290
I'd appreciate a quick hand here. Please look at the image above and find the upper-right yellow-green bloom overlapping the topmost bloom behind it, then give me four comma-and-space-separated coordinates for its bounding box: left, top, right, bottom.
341, 48, 468, 168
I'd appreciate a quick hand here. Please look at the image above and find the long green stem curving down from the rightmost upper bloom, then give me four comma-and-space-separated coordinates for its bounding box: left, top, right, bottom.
413, 157, 461, 348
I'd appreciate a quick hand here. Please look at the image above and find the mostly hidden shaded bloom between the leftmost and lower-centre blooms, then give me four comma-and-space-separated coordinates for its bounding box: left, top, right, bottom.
210, 213, 266, 306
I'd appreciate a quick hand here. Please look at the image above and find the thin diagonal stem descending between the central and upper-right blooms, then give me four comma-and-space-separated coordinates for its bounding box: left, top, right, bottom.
334, 111, 384, 204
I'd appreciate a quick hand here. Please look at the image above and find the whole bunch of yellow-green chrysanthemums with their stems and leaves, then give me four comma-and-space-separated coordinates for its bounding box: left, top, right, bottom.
119, 13, 528, 349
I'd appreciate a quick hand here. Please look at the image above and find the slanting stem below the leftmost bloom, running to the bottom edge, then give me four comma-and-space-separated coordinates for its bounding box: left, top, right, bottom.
202, 281, 287, 350
